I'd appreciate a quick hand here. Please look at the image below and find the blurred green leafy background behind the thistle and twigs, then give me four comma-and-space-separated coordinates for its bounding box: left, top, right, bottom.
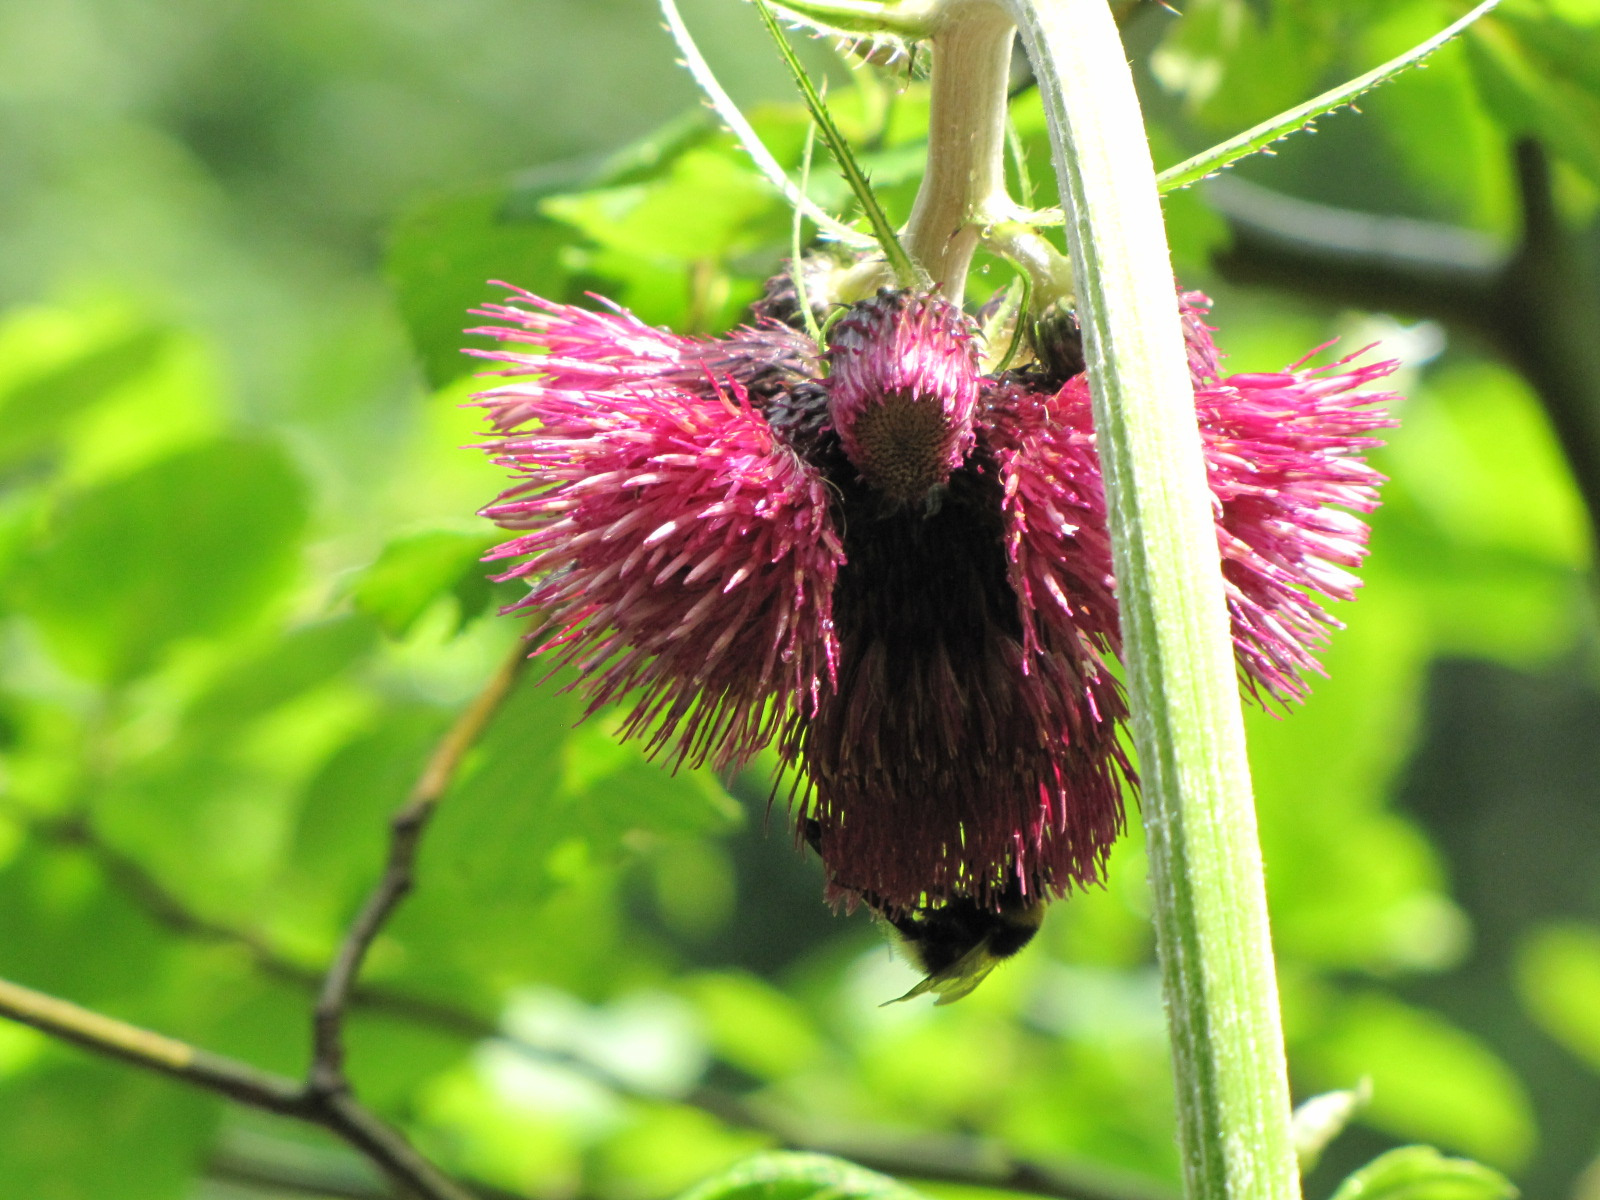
0, 0, 1600, 1200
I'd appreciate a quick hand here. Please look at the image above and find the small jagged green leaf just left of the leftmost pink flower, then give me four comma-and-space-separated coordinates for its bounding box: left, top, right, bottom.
350, 530, 498, 638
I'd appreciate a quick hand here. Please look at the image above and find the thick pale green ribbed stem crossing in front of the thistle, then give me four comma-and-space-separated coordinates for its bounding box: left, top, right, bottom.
1003, 0, 1299, 1200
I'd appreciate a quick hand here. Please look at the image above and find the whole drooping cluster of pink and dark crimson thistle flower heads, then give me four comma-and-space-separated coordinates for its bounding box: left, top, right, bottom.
475, 291, 1394, 918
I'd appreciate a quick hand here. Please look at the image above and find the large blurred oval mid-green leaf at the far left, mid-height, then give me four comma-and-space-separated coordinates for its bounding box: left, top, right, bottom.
14, 440, 307, 680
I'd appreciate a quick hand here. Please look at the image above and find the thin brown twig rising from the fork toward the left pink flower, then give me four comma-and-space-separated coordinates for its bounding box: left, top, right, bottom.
307, 640, 528, 1096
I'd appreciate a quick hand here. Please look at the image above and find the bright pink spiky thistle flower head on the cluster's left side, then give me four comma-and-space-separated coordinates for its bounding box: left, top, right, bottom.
480, 293, 842, 766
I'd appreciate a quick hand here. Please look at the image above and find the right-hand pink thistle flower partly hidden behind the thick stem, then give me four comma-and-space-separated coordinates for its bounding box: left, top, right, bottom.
995, 293, 1397, 701
